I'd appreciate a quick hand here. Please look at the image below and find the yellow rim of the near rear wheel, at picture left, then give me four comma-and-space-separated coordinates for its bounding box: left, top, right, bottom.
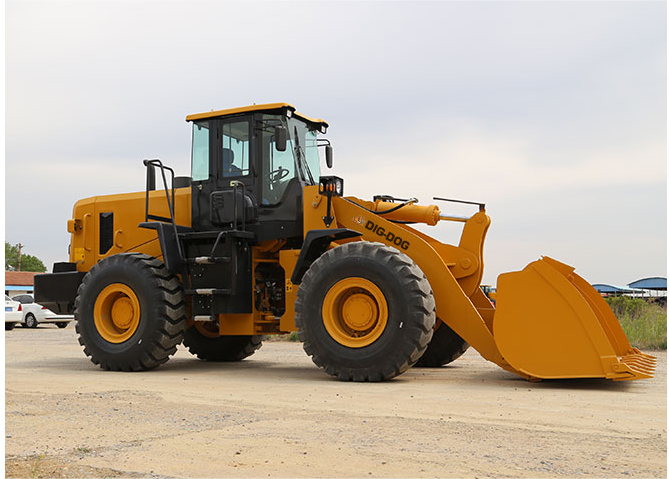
93, 283, 140, 343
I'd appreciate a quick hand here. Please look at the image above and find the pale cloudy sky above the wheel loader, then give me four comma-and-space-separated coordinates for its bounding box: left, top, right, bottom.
5, 0, 667, 286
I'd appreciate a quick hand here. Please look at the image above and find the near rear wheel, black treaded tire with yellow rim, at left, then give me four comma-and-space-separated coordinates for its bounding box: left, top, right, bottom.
74, 253, 187, 371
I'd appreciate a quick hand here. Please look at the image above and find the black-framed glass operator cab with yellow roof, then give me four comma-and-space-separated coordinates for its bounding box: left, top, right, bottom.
186, 103, 331, 241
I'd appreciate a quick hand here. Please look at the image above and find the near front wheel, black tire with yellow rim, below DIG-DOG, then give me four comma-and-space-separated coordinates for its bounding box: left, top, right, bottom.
295, 241, 436, 381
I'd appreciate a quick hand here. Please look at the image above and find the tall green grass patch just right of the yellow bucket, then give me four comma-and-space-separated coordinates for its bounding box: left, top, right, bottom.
606, 296, 667, 350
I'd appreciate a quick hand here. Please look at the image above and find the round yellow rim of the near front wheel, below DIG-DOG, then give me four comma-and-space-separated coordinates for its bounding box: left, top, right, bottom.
322, 277, 388, 348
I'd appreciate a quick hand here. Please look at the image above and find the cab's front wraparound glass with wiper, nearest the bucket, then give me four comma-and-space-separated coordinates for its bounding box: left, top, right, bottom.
261, 115, 320, 205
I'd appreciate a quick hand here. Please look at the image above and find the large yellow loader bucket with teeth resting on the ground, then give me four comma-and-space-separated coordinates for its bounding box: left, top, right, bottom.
493, 256, 655, 380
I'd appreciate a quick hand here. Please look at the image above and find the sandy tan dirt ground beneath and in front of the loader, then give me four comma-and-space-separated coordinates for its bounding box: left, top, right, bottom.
5, 325, 667, 479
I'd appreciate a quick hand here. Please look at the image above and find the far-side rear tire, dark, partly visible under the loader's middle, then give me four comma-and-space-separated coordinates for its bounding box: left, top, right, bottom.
184, 322, 264, 362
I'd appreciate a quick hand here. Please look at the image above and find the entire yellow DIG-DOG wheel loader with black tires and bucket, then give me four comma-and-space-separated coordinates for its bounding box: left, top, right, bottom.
35, 103, 655, 381
